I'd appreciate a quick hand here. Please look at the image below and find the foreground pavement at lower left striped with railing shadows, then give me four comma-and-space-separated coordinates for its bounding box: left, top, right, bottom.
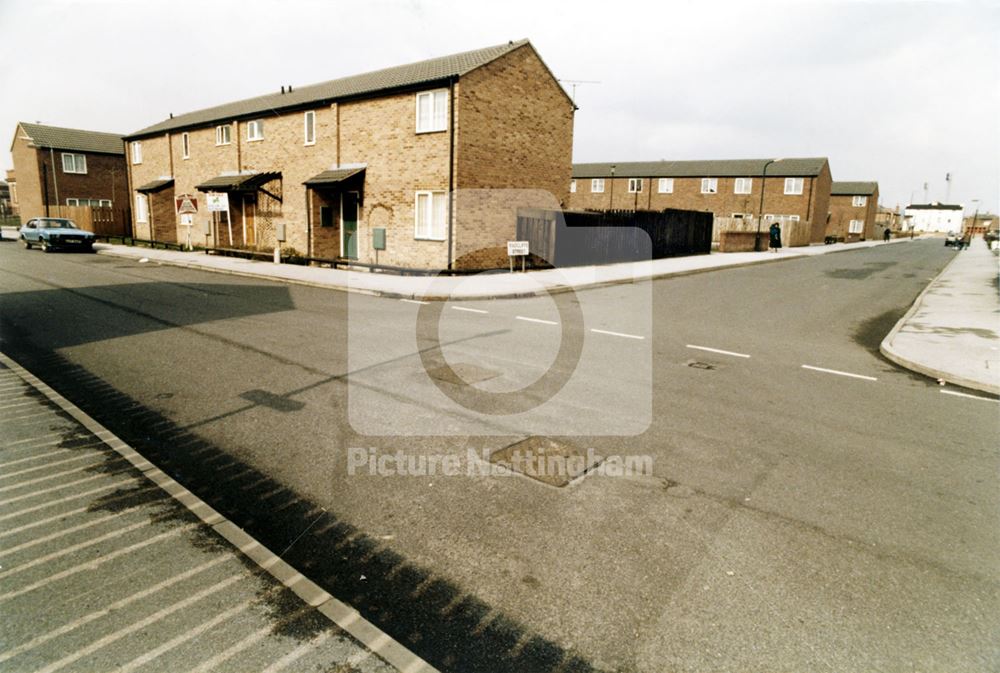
0, 354, 434, 673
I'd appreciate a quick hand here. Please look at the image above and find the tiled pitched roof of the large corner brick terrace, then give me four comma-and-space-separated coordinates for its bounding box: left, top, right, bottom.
127, 40, 530, 138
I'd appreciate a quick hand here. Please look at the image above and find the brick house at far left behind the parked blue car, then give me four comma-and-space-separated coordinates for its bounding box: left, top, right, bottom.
10, 122, 129, 220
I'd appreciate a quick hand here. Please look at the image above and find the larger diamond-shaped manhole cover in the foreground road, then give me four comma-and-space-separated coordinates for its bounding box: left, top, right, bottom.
490, 435, 604, 488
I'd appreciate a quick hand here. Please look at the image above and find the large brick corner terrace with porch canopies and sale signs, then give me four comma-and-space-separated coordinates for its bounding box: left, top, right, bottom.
126, 40, 575, 269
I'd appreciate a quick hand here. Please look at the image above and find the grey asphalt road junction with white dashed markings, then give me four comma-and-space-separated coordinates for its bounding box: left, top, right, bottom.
0, 241, 1000, 672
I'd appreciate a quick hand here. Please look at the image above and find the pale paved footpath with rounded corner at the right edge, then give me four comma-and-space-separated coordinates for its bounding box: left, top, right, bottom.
881, 238, 1000, 395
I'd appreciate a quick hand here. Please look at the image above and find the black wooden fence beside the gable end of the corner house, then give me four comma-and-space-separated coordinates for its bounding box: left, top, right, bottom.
517, 209, 713, 266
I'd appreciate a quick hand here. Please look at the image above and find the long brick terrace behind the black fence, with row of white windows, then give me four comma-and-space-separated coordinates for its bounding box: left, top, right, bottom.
569, 157, 831, 243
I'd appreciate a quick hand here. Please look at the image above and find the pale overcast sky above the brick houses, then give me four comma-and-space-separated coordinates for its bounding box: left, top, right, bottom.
0, 0, 1000, 212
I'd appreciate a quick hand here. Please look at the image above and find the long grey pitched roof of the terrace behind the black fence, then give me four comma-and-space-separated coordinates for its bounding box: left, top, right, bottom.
573, 157, 827, 178
